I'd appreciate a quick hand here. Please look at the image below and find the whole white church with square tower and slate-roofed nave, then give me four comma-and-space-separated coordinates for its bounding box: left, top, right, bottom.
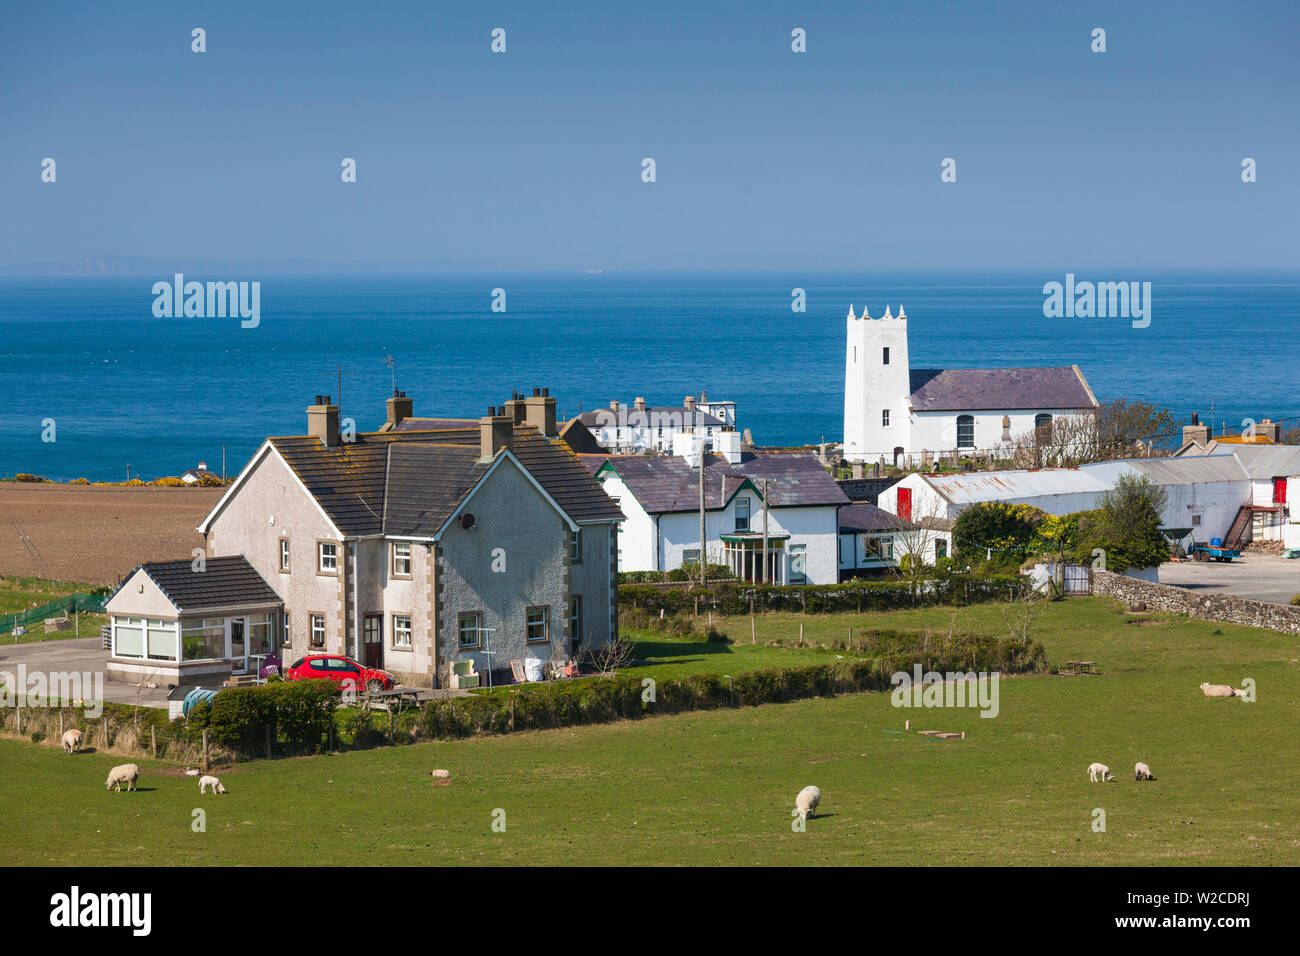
844, 306, 1097, 464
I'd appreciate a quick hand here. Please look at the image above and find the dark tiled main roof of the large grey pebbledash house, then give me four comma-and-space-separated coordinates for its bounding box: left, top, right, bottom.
269, 421, 623, 536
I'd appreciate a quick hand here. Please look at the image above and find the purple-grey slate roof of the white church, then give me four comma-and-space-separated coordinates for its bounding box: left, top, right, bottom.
910, 365, 1097, 411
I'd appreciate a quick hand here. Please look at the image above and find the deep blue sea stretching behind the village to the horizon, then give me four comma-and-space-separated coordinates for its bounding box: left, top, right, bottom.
0, 272, 1300, 481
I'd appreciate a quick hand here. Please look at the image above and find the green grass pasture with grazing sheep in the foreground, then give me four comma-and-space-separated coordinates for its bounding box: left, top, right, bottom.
0, 598, 1300, 866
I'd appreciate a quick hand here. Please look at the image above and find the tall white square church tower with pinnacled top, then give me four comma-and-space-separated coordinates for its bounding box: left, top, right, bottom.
844, 306, 911, 464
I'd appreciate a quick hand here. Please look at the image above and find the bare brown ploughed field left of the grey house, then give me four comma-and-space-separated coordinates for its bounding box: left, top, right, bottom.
0, 481, 225, 584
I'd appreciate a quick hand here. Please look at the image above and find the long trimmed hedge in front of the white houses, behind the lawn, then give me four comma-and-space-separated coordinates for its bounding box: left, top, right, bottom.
619, 575, 1024, 614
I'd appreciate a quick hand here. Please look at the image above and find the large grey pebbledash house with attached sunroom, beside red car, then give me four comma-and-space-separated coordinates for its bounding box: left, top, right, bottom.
108, 390, 623, 687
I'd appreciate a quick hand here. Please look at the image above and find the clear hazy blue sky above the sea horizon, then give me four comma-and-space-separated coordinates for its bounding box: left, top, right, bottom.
0, 0, 1300, 273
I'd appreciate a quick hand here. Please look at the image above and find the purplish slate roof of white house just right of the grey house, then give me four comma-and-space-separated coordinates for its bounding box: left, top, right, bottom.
595, 454, 849, 514
